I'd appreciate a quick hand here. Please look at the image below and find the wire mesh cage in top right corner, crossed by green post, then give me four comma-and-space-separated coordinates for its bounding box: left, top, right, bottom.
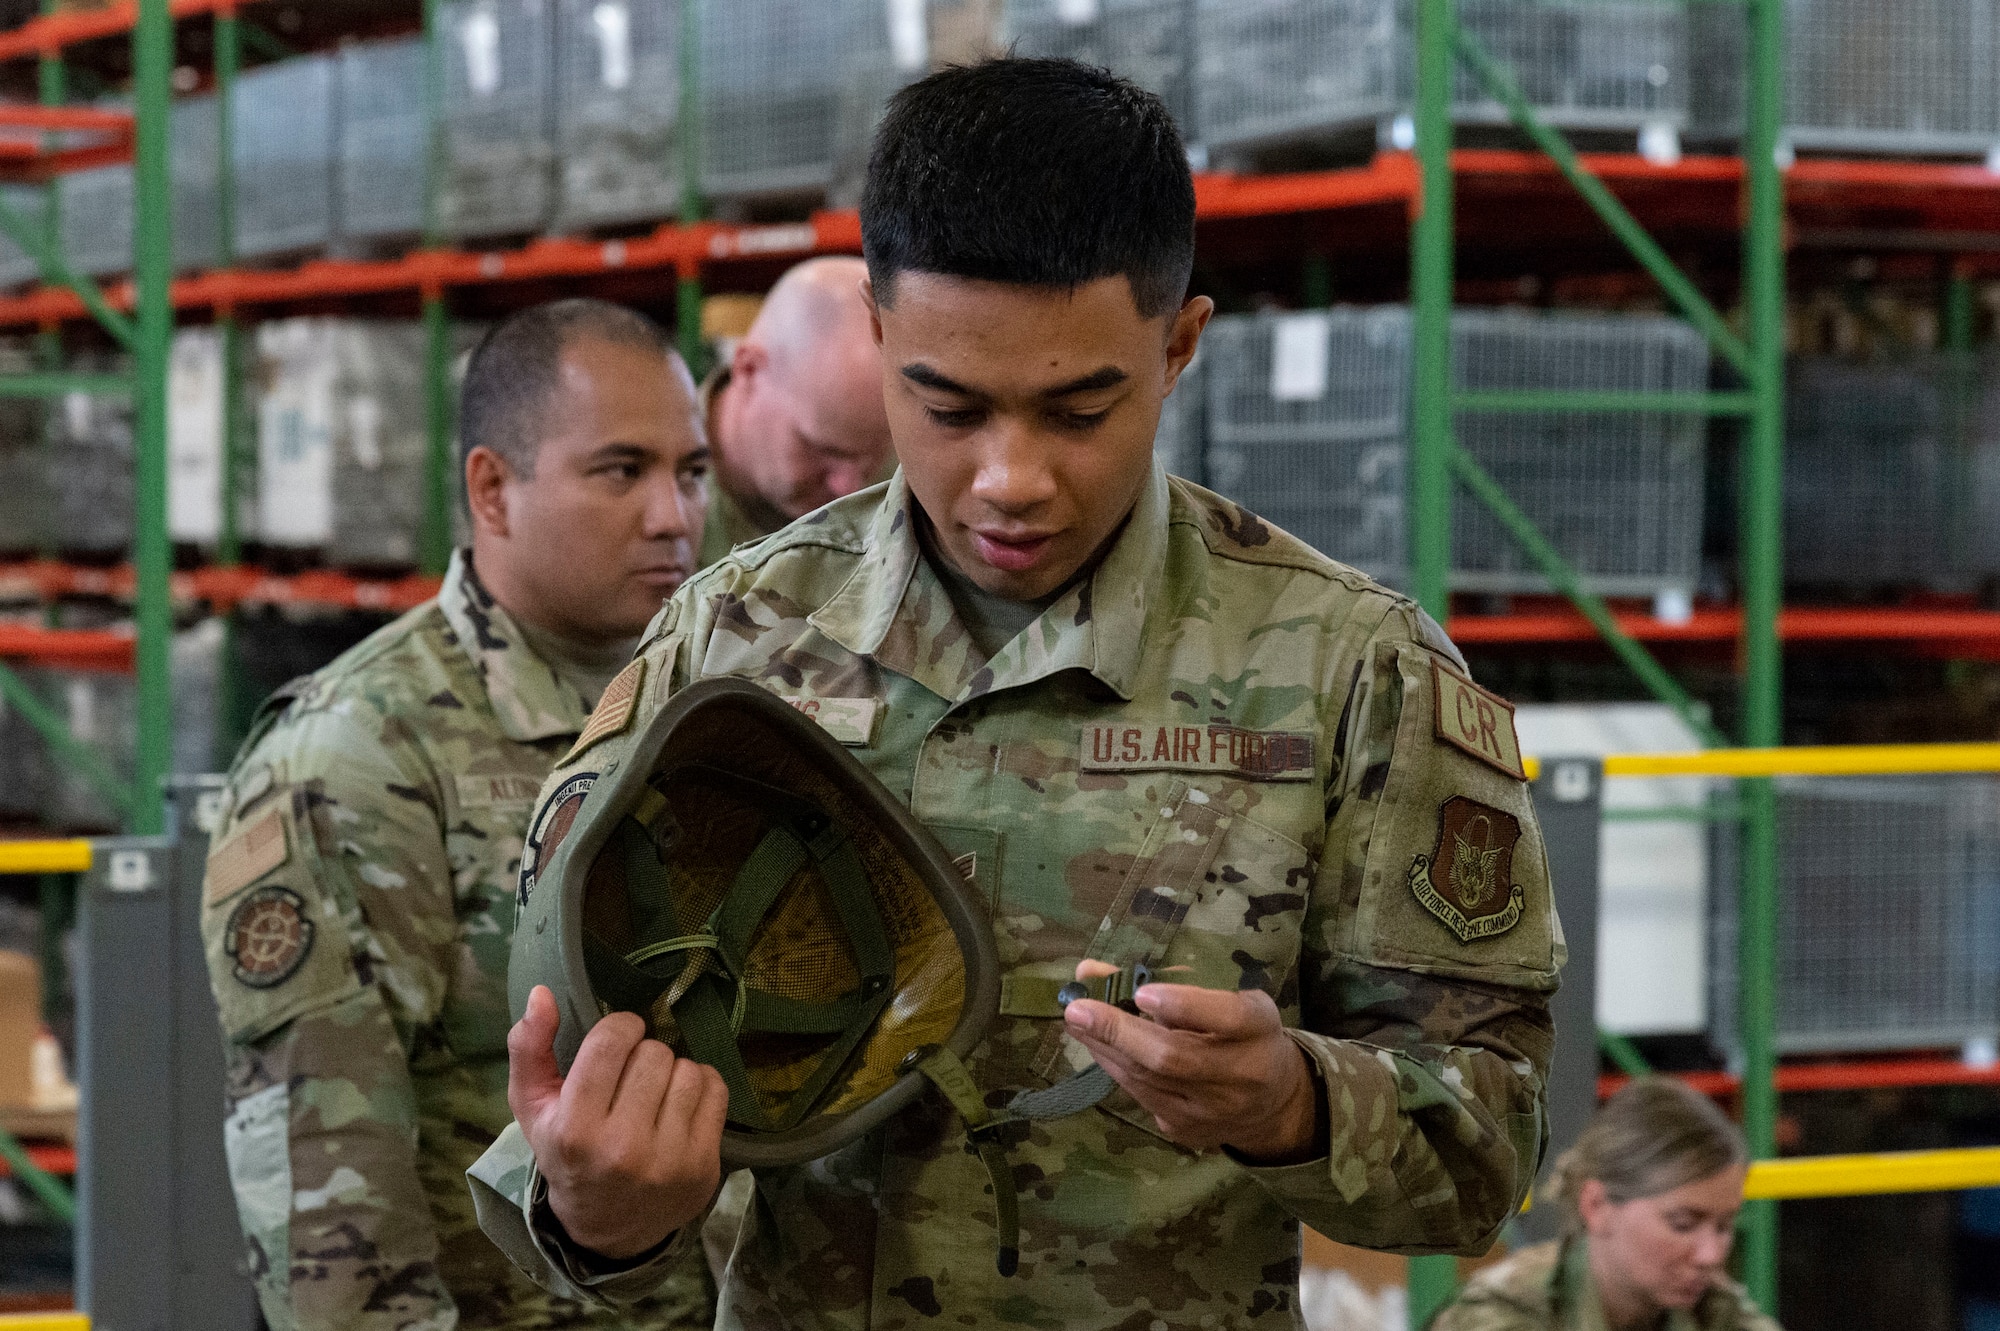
1694, 0, 2000, 154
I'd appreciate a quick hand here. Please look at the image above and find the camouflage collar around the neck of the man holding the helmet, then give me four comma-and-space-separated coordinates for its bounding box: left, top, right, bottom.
810, 462, 1168, 701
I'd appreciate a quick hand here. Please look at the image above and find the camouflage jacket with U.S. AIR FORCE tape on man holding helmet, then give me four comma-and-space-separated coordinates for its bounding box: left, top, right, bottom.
472, 468, 1560, 1331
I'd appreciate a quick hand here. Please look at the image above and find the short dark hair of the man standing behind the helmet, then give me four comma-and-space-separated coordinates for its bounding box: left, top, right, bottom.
458, 298, 678, 478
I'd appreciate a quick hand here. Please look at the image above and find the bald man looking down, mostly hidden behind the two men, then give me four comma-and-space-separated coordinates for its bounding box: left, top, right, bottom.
700, 258, 888, 568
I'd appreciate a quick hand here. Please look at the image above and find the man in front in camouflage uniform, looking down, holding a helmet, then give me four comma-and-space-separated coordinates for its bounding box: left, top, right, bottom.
472, 60, 1562, 1331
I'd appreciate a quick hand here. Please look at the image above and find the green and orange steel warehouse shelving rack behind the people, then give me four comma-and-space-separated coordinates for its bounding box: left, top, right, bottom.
0, 0, 2000, 1311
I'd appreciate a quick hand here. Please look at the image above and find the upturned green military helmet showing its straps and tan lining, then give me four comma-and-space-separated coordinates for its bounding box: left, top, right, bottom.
508, 679, 1000, 1169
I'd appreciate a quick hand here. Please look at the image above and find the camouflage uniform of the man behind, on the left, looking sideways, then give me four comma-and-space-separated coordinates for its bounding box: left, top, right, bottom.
202, 554, 712, 1331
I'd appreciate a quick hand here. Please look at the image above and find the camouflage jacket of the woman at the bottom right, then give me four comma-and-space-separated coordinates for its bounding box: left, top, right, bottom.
1430, 1239, 1778, 1331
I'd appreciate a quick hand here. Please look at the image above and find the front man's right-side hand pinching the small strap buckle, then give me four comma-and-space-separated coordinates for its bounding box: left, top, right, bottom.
1064, 961, 1326, 1165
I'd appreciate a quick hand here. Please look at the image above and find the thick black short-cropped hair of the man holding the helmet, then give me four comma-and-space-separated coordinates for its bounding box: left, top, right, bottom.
862, 56, 1194, 318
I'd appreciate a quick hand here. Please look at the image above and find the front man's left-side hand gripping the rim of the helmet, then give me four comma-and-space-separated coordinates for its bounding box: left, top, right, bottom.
506, 985, 730, 1259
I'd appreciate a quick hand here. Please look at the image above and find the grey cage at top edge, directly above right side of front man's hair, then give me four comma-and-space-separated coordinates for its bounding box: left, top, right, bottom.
1004, 0, 1196, 142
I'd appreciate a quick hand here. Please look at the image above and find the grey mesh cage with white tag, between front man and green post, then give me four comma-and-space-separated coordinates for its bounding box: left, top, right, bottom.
1202, 308, 1410, 580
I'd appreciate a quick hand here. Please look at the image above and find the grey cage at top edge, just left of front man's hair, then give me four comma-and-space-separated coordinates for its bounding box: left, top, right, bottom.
696, 0, 926, 200
